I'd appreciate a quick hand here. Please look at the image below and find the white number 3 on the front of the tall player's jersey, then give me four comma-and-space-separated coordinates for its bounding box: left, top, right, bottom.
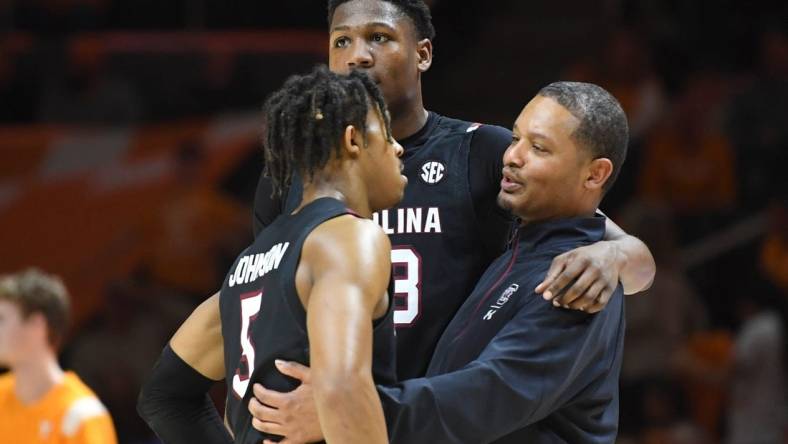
391, 246, 421, 327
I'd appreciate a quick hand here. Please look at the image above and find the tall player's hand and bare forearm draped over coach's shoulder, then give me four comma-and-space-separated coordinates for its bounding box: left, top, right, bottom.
536, 218, 657, 313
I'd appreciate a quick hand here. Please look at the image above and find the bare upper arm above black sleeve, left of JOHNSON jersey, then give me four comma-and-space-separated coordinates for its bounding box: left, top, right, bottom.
170, 292, 224, 381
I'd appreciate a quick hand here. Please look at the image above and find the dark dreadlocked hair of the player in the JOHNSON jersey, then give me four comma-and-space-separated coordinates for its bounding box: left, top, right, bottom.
263, 65, 391, 195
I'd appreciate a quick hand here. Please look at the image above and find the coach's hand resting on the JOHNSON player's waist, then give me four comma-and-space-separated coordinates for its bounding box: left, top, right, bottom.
249, 360, 323, 444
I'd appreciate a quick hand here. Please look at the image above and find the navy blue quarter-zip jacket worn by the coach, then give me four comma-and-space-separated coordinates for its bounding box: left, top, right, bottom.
379, 216, 624, 444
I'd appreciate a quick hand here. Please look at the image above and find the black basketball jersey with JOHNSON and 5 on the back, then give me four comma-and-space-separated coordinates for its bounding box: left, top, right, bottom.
219, 198, 396, 444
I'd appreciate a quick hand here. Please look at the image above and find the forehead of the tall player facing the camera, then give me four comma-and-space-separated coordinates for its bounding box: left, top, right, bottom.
330, 0, 409, 32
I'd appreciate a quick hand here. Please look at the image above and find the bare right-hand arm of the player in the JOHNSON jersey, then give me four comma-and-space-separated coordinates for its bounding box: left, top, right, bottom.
294, 216, 391, 443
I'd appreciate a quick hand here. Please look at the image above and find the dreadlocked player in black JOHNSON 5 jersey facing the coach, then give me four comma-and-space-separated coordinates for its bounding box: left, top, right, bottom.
143, 67, 407, 444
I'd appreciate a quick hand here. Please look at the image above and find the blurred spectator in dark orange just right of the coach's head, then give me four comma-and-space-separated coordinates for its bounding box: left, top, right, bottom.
639, 72, 738, 239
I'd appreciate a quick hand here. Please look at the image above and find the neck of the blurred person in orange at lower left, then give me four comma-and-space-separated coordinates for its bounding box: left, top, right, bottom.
12, 351, 64, 404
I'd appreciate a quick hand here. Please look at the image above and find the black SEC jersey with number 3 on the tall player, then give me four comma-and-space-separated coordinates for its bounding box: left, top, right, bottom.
285, 113, 490, 380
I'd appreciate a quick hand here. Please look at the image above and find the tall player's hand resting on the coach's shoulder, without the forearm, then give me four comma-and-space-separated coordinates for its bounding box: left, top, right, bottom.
535, 241, 624, 313
